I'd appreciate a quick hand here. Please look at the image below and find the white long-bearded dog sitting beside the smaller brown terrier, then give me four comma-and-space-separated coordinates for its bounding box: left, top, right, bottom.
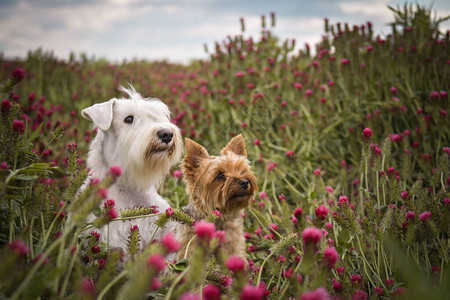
81, 86, 182, 252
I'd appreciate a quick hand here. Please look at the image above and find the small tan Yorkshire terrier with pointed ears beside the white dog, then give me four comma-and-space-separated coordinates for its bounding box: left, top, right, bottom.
176, 135, 258, 259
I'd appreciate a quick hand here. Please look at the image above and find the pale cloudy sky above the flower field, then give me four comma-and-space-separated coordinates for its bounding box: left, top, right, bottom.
0, 0, 450, 63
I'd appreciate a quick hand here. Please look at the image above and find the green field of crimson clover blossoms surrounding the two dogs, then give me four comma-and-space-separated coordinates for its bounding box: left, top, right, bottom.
0, 6, 450, 299
